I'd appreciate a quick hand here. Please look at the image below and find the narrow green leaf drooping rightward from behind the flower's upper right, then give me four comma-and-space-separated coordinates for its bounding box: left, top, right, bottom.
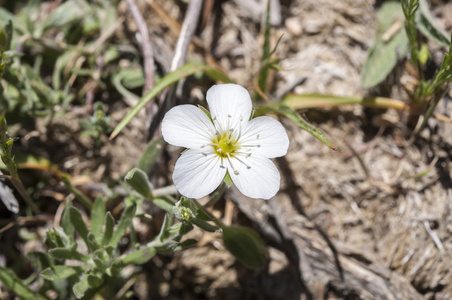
256, 103, 336, 150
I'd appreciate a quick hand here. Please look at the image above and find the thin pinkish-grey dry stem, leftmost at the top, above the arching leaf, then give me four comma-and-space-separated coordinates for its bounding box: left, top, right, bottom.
126, 0, 155, 94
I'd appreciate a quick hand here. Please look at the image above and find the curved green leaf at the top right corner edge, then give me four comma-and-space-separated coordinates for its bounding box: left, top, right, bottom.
415, 0, 450, 47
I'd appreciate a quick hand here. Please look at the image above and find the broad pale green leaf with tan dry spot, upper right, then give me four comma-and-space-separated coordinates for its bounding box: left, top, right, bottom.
361, 1, 408, 88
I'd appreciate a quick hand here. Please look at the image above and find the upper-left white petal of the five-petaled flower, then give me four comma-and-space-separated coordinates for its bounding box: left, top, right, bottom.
162, 104, 215, 148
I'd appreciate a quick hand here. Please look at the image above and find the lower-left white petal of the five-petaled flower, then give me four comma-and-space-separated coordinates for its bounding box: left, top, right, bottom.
173, 149, 226, 198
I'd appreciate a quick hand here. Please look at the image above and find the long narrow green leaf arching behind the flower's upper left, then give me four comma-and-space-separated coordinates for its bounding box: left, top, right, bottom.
110, 63, 233, 139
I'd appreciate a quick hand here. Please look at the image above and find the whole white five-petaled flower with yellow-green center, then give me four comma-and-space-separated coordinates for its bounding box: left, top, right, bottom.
162, 84, 289, 199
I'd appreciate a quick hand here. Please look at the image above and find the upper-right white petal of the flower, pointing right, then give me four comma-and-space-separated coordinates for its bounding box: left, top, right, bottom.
239, 117, 289, 158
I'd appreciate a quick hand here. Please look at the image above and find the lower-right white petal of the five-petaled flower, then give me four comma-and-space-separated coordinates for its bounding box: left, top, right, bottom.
228, 154, 280, 199
